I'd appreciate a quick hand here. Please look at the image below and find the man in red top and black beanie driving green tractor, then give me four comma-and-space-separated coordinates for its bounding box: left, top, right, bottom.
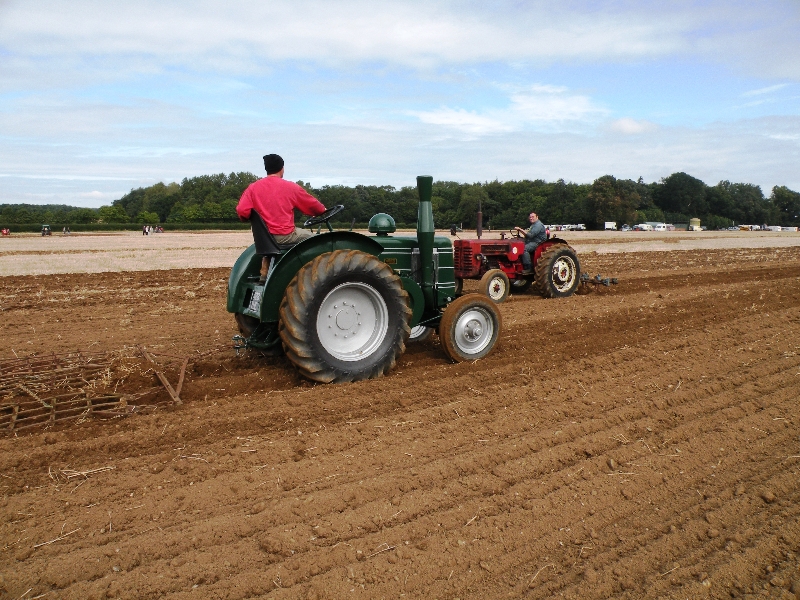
236, 154, 325, 245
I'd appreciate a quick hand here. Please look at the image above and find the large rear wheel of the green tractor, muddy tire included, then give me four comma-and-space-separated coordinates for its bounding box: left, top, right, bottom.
279, 250, 412, 383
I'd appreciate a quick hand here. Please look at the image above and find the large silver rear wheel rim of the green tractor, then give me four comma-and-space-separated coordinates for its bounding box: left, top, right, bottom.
317, 282, 389, 362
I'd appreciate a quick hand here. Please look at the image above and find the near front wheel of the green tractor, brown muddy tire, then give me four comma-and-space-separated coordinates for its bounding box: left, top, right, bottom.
439, 294, 502, 362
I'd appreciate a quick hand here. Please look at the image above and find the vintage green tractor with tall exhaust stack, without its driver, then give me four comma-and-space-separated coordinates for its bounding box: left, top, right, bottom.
227, 176, 501, 383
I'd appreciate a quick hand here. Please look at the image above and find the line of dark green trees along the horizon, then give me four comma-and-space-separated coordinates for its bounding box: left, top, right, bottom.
0, 172, 800, 229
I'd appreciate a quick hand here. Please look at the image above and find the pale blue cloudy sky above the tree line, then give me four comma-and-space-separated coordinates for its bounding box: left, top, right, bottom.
0, 0, 800, 207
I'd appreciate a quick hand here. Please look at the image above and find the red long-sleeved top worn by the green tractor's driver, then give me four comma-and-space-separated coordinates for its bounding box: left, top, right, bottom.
236, 177, 325, 235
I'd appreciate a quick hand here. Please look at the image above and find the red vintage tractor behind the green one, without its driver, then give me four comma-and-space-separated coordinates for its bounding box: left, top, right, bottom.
453, 234, 581, 304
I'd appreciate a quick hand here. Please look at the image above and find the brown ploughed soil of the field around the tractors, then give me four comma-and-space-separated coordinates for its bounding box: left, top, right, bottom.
0, 248, 800, 599
